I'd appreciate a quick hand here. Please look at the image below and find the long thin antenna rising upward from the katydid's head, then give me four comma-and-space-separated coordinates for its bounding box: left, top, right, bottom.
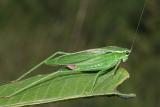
130, 0, 147, 53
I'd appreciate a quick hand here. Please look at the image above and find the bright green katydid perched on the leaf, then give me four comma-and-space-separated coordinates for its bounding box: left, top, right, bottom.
0, 46, 130, 97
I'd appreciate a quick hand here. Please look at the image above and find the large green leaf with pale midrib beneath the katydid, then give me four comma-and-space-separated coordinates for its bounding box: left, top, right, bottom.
0, 68, 135, 107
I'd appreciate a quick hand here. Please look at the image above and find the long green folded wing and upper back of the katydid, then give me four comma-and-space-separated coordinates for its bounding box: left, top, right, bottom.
45, 46, 129, 65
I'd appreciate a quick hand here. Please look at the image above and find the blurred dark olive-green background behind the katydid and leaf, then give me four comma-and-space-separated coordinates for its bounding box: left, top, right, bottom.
0, 0, 160, 107
